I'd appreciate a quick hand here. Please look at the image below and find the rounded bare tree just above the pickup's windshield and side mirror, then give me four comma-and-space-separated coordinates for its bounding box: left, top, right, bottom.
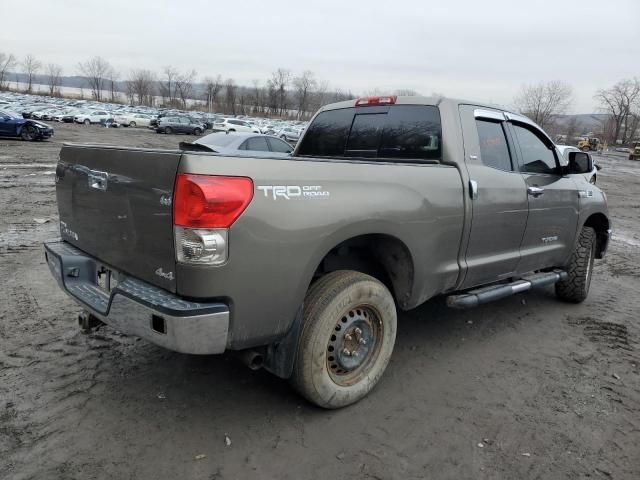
514, 80, 573, 128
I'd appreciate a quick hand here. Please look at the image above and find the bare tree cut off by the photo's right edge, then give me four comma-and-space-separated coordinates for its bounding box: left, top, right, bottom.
594, 78, 640, 143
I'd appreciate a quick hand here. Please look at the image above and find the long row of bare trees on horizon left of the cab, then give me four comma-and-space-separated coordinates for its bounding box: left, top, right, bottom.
0, 52, 353, 119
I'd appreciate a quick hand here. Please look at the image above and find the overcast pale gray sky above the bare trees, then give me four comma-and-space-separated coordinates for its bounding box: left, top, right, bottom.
0, 0, 640, 113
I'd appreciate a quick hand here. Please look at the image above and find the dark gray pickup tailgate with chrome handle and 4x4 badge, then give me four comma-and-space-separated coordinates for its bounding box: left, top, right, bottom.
56, 145, 181, 292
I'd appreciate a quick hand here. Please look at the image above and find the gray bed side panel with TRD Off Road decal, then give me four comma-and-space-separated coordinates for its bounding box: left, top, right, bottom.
176, 154, 464, 348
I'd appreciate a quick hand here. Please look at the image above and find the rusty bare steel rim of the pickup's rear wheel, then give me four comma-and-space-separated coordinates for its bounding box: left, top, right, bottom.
326, 305, 384, 387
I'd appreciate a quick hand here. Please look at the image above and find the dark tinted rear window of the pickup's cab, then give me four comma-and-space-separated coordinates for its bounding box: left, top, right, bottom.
298, 105, 442, 160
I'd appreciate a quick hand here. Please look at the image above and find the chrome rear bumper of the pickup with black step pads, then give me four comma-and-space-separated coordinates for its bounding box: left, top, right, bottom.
45, 241, 229, 354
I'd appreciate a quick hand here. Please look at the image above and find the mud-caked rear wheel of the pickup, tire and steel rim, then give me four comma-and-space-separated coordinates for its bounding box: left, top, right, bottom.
290, 270, 397, 408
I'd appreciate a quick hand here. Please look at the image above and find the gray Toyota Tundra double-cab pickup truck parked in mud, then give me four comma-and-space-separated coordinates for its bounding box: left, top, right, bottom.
45, 97, 611, 408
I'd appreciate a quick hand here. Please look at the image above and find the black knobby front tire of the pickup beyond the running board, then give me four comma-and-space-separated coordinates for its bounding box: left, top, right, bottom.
556, 227, 596, 303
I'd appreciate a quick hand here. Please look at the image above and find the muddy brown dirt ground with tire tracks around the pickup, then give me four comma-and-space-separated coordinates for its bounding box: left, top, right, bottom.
0, 124, 640, 480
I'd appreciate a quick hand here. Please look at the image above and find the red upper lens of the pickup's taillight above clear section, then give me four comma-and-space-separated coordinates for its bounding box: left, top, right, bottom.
173, 173, 253, 228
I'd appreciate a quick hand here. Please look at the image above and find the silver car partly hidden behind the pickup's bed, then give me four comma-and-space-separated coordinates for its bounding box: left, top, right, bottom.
180, 132, 293, 158
